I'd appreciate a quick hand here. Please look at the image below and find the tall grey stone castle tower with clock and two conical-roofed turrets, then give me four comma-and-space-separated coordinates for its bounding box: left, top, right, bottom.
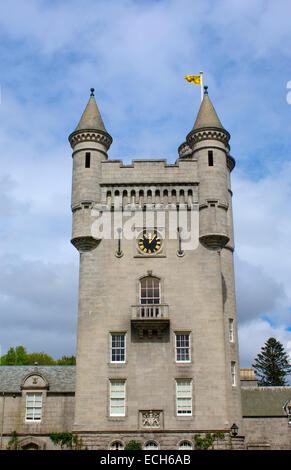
69, 90, 242, 449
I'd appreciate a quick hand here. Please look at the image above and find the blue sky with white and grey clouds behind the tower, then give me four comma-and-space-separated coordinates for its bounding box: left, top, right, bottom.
0, 0, 291, 367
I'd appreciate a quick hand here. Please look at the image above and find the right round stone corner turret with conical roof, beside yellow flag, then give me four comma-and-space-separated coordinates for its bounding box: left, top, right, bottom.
186, 87, 234, 249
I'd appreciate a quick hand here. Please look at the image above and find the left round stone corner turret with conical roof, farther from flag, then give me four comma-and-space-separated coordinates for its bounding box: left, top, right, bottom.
69, 88, 112, 251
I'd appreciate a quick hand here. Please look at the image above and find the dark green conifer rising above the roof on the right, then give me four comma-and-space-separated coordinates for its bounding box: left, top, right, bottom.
252, 338, 291, 386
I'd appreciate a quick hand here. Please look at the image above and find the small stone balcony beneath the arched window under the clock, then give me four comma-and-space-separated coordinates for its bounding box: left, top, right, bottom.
131, 304, 170, 339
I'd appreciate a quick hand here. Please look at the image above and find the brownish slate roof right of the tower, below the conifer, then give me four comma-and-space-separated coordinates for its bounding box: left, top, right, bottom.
241, 387, 291, 416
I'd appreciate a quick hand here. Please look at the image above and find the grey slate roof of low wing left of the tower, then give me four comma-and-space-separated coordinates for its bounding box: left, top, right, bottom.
0, 366, 76, 392
